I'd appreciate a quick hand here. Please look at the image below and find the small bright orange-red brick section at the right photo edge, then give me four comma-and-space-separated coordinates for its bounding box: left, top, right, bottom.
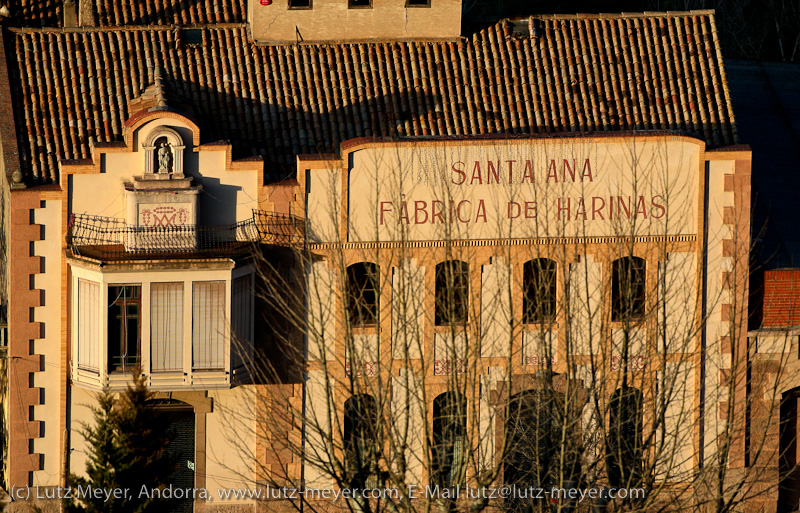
761, 269, 800, 328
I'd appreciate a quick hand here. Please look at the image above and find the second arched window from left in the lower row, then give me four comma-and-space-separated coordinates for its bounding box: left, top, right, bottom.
431, 392, 467, 487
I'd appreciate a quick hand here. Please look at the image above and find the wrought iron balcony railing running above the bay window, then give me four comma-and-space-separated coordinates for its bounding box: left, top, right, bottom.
67, 210, 305, 260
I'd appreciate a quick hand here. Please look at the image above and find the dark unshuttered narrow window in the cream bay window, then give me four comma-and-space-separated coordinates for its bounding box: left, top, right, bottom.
108, 285, 142, 372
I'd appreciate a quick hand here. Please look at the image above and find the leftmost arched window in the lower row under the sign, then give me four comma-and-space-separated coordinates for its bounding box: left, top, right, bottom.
344, 394, 379, 489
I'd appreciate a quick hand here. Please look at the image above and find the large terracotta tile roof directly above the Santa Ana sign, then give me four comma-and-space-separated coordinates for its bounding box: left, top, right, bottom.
12, 11, 737, 182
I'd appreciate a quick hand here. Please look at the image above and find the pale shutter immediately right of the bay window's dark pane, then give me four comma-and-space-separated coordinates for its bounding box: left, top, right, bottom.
150, 282, 183, 372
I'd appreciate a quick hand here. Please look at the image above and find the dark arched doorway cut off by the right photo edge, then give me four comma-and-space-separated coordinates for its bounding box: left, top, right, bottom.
778, 387, 800, 513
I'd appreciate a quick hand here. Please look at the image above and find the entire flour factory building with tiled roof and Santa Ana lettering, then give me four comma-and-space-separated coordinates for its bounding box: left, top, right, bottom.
0, 0, 793, 511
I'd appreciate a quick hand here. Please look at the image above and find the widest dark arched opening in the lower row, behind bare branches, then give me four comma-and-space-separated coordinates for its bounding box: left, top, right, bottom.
503, 389, 580, 511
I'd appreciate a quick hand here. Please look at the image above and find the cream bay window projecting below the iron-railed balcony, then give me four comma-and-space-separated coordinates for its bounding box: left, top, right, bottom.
70, 266, 254, 391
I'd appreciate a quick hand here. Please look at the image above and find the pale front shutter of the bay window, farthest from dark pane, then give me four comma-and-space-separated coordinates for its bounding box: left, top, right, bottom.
192, 281, 226, 370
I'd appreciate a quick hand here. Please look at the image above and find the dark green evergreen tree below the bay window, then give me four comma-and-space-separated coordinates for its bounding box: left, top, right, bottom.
68, 375, 175, 513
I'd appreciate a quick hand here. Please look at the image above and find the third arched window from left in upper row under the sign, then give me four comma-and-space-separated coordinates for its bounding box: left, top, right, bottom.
522, 258, 556, 323
